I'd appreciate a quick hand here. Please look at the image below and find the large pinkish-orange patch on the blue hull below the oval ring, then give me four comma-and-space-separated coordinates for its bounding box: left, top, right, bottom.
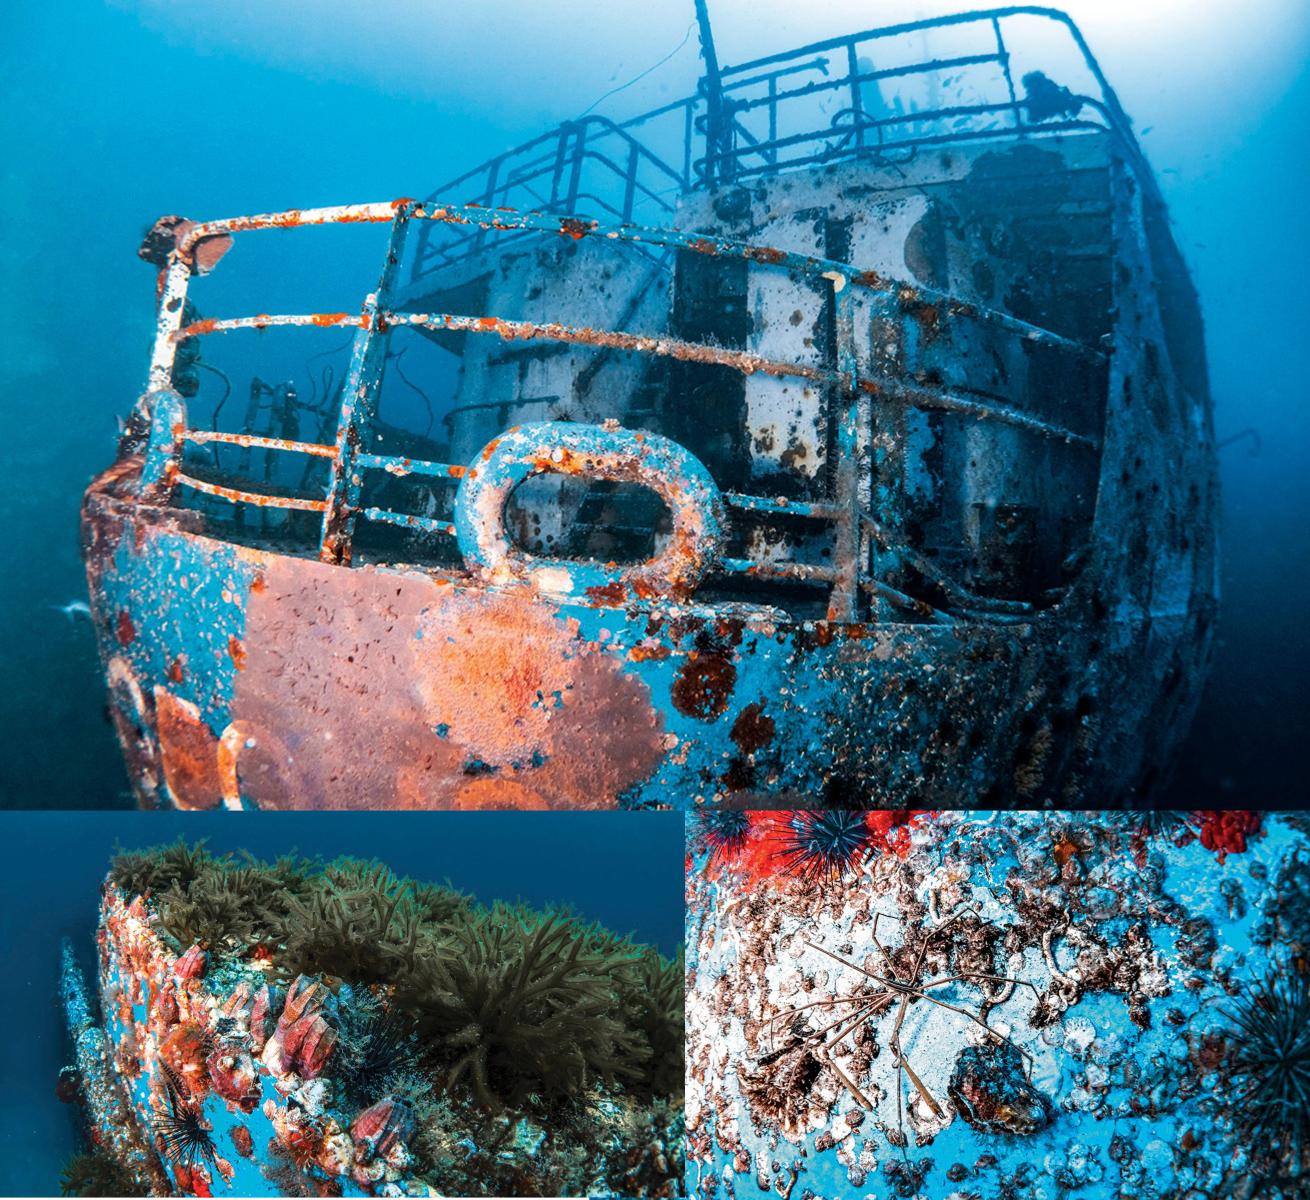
232, 559, 664, 808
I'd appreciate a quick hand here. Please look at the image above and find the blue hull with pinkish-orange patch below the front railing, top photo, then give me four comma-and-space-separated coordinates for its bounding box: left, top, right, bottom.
84, 460, 1214, 810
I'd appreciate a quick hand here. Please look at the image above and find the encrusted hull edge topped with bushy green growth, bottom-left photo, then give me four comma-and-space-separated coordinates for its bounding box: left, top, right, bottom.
62, 844, 683, 1196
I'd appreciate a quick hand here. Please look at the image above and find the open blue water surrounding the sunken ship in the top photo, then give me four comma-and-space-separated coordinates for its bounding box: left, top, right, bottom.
0, 0, 1310, 807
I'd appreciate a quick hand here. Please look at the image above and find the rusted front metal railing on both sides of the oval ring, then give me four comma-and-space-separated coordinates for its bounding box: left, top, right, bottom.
143, 199, 1103, 621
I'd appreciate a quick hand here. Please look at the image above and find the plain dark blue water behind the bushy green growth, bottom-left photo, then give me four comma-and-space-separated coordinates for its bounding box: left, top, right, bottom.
0, 812, 683, 1196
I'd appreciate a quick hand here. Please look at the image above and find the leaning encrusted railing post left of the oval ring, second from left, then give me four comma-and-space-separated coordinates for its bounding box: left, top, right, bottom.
318, 212, 411, 566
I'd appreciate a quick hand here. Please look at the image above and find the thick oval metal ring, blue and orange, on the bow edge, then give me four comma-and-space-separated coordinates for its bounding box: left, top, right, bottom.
455, 421, 724, 600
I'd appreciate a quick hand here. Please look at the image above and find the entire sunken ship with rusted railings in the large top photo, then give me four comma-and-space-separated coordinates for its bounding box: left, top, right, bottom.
84, 5, 1217, 808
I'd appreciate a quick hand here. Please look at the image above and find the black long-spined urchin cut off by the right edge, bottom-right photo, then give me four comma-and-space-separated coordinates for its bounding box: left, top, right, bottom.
1221, 971, 1310, 1174
